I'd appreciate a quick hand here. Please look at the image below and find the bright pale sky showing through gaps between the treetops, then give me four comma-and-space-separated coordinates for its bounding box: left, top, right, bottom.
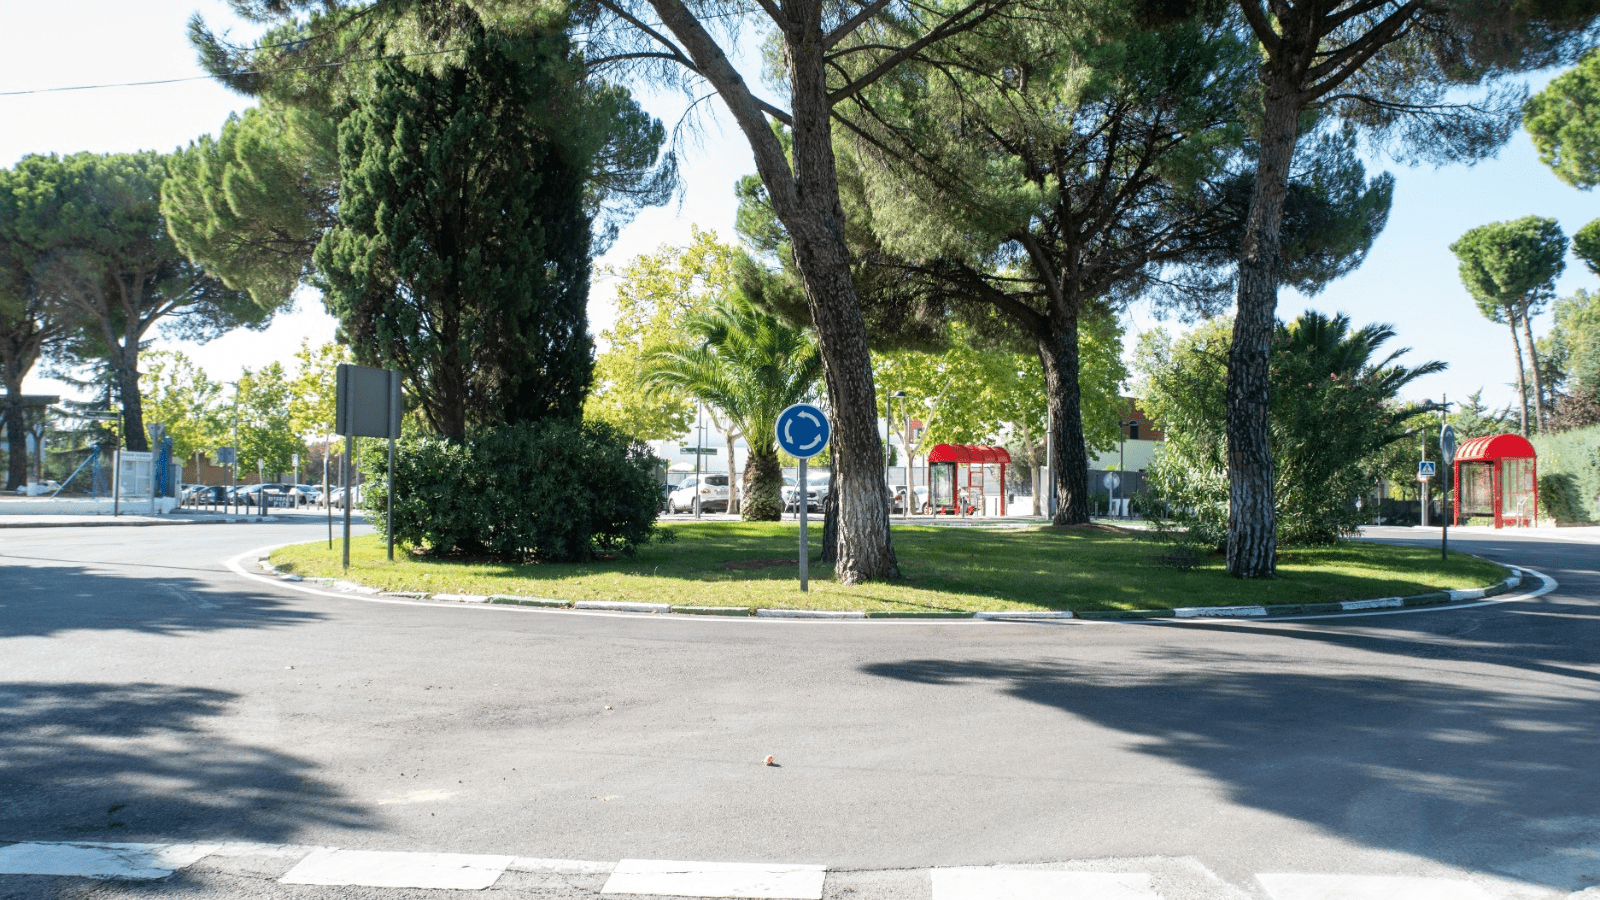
0, 0, 1600, 407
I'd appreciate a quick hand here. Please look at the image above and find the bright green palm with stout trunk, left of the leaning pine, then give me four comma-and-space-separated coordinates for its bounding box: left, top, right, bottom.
643, 295, 822, 522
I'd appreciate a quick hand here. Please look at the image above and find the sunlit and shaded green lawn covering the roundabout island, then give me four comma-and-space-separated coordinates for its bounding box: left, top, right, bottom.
272, 522, 1506, 613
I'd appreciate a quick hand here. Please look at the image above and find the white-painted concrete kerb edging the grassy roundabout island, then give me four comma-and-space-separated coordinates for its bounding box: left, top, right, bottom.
224, 543, 1555, 621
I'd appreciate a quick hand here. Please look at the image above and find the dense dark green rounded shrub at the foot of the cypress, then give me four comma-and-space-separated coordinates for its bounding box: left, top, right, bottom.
365, 421, 661, 562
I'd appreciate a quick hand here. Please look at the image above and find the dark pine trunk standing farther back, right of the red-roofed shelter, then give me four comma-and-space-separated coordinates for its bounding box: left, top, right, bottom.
1038, 315, 1090, 525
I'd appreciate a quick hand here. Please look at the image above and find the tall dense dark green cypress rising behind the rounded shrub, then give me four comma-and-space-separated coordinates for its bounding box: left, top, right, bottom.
315, 30, 646, 442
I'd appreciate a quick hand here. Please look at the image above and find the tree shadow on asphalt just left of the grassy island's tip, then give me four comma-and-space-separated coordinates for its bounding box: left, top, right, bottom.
0, 557, 323, 639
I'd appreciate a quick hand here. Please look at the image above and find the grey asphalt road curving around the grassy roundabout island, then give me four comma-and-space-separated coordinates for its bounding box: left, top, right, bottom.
0, 517, 1600, 900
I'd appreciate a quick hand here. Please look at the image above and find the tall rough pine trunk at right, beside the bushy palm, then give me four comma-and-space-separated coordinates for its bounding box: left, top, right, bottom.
1227, 80, 1301, 578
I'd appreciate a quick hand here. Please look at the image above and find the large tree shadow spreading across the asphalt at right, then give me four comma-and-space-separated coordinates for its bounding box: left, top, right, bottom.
862, 604, 1600, 890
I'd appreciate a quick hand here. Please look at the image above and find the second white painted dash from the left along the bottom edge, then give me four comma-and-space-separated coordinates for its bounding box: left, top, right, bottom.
278, 850, 515, 890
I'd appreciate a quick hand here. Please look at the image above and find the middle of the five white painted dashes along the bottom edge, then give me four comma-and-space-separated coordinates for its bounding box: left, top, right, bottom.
600, 860, 827, 900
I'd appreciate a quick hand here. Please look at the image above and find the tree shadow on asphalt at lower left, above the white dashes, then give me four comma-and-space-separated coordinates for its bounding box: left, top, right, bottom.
0, 682, 371, 842
